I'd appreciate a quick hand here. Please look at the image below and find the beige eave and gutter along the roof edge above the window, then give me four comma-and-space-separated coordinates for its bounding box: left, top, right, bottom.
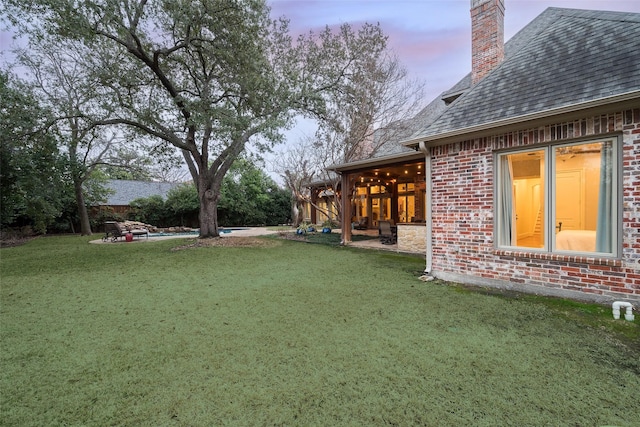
400, 90, 640, 148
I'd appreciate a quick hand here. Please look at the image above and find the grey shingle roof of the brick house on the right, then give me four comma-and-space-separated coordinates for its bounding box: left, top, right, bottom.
405, 8, 640, 145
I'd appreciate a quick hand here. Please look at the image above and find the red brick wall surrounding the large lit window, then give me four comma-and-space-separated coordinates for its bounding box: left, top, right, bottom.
431, 109, 640, 301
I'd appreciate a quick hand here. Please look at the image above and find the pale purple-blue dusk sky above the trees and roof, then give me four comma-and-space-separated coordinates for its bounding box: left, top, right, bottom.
269, 0, 640, 100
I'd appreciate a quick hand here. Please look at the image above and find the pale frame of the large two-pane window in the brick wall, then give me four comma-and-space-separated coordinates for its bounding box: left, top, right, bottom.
493, 134, 624, 259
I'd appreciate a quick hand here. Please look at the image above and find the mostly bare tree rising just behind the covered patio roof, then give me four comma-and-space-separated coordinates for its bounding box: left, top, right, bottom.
310, 48, 424, 224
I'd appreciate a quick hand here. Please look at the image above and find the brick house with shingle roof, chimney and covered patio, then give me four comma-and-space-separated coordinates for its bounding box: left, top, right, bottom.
336, 0, 640, 302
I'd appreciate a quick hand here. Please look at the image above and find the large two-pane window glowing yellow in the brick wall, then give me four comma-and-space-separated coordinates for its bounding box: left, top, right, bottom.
495, 138, 619, 255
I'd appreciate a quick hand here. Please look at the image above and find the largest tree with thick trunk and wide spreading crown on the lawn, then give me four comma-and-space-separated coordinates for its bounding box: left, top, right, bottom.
6, 0, 384, 237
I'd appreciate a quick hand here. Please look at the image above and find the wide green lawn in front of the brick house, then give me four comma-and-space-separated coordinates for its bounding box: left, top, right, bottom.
0, 236, 640, 426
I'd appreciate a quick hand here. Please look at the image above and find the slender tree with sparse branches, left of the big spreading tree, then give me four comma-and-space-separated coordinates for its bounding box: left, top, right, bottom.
17, 35, 133, 235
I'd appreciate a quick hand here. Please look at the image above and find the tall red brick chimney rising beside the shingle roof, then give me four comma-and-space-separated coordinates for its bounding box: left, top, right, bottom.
471, 0, 504, 84
